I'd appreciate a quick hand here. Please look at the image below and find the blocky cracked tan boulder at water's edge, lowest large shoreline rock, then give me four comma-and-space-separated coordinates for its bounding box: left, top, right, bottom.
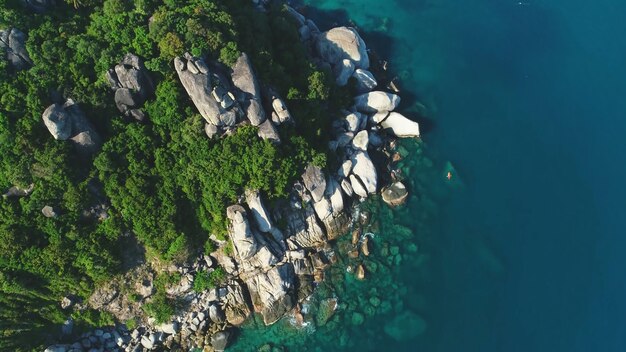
246, 263, 295, 325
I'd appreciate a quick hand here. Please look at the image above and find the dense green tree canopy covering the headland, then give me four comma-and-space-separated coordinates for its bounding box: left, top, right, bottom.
0, 0, 348, 351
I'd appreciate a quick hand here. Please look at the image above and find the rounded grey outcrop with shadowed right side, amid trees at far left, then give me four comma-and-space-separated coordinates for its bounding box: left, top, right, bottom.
42, 99, 102, 154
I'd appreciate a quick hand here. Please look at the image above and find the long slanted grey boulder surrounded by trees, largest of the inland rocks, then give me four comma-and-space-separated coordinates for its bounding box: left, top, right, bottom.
174, 53, 237, 127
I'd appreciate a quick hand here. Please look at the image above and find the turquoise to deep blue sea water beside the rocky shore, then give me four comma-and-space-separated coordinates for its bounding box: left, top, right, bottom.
232, 0, 626, 352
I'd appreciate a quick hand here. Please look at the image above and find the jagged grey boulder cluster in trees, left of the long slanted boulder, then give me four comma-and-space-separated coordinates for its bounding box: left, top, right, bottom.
106, 53, 154, 121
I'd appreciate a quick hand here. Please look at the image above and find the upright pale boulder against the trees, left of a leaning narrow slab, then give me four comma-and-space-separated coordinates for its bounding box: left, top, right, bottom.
226, 205, 257, 261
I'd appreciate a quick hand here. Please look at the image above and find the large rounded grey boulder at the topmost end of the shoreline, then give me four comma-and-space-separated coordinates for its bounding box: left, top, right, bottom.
317, 27, 369, 69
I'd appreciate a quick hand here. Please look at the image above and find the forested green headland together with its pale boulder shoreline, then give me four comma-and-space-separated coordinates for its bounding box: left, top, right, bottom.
0, 0, 420, 352
